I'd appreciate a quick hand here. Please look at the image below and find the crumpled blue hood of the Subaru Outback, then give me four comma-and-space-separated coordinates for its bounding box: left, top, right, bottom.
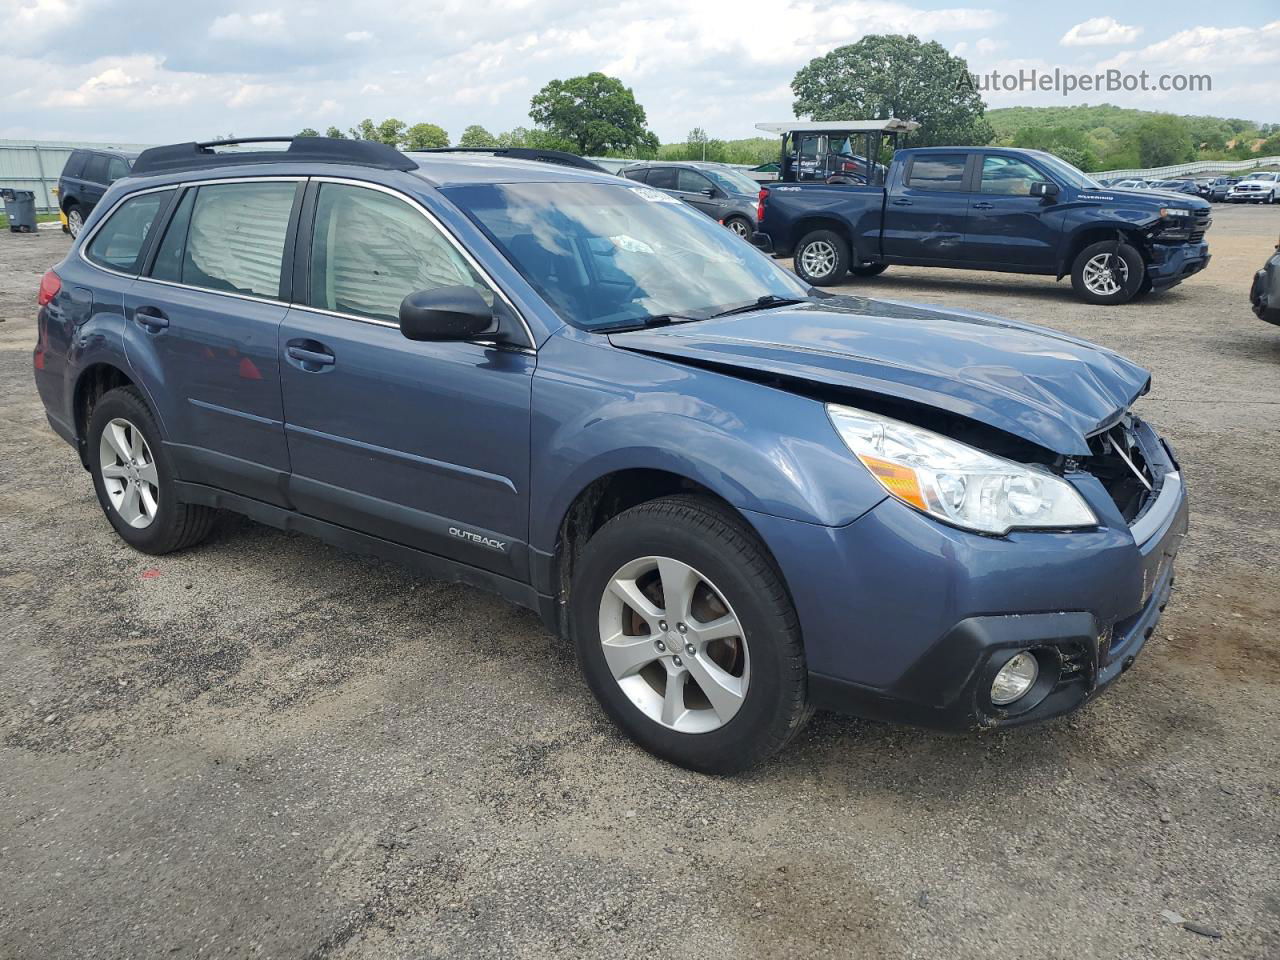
609, 297, 1151, 456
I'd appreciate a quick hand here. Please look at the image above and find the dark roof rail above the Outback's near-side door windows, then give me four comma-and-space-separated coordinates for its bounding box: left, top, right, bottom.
132, 137, 417, 177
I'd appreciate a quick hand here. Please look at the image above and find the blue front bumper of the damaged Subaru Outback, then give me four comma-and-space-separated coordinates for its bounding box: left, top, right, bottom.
762, 425, 1188, 730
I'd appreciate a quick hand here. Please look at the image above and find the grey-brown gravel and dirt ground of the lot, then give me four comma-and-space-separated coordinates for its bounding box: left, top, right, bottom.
0, 207, 1280, 960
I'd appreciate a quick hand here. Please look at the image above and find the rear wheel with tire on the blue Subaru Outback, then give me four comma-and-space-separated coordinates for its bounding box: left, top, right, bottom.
87, 387, 216, 554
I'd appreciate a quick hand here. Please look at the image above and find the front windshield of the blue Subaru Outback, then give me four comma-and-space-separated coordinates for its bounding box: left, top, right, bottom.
443, 180, 806, 330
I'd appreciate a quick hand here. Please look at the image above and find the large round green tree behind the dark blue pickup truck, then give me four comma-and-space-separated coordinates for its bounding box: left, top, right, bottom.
791, 35, 995, 146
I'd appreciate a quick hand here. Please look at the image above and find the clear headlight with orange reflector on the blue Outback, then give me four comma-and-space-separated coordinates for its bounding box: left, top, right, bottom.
827, 403, 1098, 534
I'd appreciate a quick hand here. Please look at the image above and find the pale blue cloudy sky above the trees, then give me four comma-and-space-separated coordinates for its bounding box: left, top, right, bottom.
0, 0, 1280, 143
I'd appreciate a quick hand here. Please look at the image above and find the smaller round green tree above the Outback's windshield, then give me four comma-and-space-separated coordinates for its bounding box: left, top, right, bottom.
529, 72, 658, 155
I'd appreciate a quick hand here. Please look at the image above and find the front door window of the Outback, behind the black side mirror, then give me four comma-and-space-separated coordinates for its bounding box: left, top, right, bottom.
304, 183, 493, 324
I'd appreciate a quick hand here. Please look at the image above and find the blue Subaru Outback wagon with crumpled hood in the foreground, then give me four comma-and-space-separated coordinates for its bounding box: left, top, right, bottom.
35, 138, 1187, 772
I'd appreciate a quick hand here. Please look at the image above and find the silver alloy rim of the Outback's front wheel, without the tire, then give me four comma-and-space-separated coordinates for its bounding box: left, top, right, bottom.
599, 557, 751, 733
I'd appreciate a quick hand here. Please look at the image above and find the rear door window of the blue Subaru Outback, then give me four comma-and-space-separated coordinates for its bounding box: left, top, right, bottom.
176, 180, 297, 300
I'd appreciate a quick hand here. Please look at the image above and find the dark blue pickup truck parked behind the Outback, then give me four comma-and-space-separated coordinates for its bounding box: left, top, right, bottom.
753, 147, 1212, 305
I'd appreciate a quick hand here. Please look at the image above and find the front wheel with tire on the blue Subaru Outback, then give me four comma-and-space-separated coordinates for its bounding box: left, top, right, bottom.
570, 495, 810, 773
